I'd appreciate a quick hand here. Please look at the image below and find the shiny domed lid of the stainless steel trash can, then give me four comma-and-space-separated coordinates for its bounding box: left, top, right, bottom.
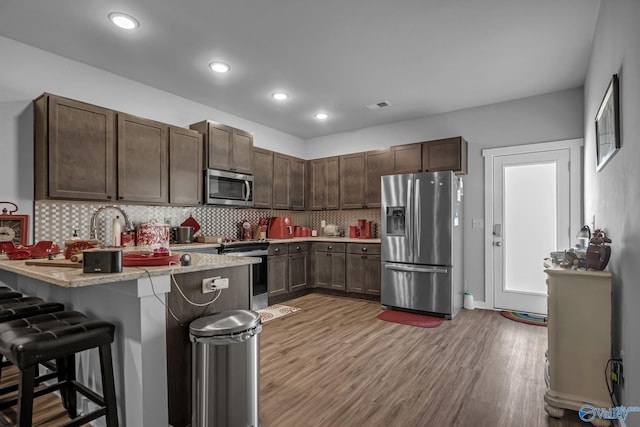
189, 310, 260, 337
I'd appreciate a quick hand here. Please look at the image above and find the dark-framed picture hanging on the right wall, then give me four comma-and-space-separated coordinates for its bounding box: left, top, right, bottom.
596, 74, 620, 171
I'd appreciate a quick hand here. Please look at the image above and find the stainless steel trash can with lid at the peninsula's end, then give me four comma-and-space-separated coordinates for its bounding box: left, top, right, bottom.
189, 310, 262, 427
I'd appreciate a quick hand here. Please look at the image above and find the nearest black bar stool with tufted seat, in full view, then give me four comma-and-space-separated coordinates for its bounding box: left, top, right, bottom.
0, 311, 118, 427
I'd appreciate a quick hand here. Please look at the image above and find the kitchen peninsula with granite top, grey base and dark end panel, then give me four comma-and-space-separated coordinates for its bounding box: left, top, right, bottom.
0, 253, 260, 427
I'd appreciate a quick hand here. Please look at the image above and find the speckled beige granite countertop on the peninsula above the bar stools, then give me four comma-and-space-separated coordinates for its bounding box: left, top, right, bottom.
0, 252, 261, 288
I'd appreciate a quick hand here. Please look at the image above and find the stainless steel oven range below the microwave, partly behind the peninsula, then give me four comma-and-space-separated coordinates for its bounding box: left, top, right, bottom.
219, 241, 269, 310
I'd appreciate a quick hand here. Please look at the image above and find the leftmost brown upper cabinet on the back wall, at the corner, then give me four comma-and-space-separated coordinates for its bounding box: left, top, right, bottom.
307, 156, 340, 210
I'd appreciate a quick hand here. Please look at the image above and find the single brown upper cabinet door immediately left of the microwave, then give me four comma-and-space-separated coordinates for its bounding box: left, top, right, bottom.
169, 126, 203, 205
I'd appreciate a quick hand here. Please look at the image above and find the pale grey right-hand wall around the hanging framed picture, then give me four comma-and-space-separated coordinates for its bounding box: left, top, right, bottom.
584, 0, 640, 414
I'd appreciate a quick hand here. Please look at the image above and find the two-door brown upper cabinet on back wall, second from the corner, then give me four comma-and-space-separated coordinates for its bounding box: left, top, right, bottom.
340, 148, 390, 209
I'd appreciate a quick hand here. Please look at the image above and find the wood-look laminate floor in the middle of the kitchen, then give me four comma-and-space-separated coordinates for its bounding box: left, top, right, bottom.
260, 294, 584, 427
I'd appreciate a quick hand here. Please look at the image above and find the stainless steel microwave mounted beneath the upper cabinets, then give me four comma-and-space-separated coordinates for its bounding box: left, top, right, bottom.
204, 169, 253, 207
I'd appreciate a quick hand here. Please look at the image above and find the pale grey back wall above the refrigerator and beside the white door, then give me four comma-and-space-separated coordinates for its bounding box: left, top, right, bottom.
307, 88, 584, 301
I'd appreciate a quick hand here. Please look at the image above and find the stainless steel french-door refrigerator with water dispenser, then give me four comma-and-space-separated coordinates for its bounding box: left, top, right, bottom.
381, 171, 464, 319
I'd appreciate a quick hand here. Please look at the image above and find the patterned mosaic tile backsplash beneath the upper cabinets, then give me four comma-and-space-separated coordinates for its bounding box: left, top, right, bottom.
33, 200, 380, 244
